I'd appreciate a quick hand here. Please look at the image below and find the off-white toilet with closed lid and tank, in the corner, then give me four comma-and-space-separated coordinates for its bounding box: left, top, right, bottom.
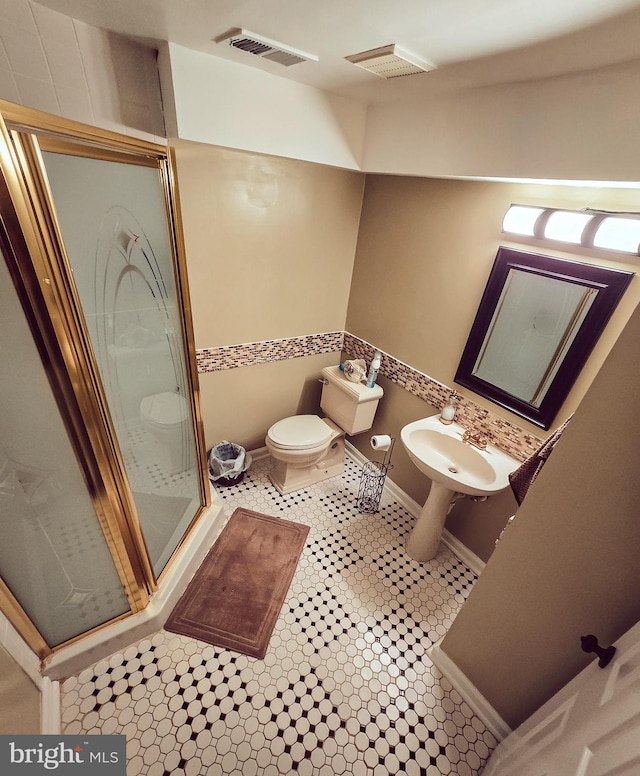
265, 366, 383, 494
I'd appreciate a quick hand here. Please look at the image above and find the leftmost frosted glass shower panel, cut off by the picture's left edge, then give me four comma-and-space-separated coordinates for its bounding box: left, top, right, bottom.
0, 246, 130, 647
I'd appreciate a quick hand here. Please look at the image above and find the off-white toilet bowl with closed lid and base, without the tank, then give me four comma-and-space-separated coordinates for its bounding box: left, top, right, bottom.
265, 415, 344, 494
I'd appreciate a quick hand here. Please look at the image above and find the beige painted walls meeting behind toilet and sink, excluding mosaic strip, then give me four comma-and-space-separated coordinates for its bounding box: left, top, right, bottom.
173, 146, 640, 560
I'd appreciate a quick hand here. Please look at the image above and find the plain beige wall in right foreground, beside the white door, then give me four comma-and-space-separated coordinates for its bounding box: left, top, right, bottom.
442, 296, 640, 727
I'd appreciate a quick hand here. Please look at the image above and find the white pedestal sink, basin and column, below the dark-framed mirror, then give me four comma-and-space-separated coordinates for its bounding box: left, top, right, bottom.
400, 415, 520, 562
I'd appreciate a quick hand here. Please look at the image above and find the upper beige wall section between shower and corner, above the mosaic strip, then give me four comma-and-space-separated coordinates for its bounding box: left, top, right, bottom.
173, 141, 364, 348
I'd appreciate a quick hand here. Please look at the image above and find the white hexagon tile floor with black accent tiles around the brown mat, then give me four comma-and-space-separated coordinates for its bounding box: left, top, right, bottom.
62, 458, 496, 776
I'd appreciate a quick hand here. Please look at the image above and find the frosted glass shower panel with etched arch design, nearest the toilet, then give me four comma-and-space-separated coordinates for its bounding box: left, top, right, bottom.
43, 151, 201, 576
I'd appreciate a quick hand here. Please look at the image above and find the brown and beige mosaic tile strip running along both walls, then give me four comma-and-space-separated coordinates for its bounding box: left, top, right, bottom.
196, 331, 543, 461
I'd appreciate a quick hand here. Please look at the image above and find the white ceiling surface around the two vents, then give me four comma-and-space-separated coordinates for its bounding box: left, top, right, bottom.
37, 0, 640, 103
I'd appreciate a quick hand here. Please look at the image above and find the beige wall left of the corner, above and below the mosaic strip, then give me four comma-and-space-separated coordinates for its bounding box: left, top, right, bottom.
172, 141, 364, 449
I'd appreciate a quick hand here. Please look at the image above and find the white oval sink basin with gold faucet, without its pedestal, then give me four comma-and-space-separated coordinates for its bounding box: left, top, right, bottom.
400, 415, 519, 496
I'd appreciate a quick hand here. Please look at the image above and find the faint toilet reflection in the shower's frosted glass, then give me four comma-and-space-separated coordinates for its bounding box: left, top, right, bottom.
140, 391, 191, 474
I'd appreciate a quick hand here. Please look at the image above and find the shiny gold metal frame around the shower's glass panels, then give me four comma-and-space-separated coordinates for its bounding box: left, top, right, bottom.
0, 100, 210, 658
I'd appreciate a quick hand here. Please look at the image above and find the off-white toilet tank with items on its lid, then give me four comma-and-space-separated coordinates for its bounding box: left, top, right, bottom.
320, 366, 384, 434
